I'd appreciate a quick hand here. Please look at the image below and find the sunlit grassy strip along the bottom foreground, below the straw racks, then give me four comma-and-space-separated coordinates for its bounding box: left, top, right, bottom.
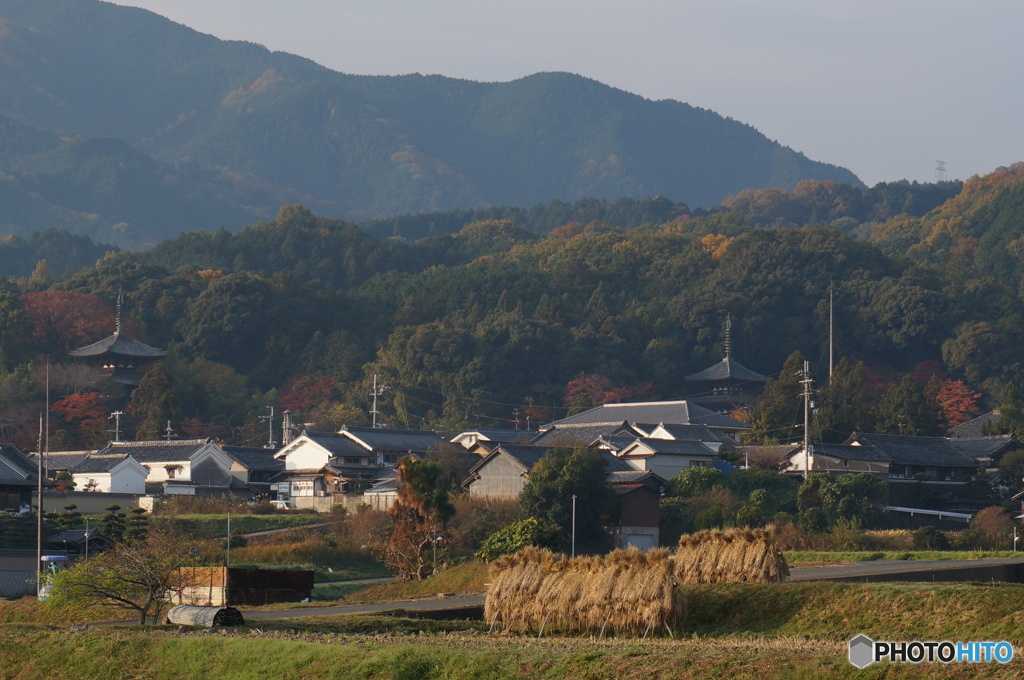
0, 630, 1024, 680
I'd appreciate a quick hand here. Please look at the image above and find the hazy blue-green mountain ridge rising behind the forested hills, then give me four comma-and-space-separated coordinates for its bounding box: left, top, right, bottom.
0, 0, 859, 245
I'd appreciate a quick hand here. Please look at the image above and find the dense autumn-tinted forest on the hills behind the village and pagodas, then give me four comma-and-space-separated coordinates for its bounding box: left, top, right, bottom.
0, 167, 1024, 449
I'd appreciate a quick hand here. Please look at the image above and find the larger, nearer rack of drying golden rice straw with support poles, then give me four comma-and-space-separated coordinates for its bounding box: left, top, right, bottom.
484, 548, 686, 634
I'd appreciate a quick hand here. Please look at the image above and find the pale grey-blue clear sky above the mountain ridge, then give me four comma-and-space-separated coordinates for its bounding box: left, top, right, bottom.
115, 0, 1024, 185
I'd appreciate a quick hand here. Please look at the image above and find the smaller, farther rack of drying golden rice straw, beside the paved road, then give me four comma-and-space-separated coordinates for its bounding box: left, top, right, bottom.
673, 528, 790, 584
